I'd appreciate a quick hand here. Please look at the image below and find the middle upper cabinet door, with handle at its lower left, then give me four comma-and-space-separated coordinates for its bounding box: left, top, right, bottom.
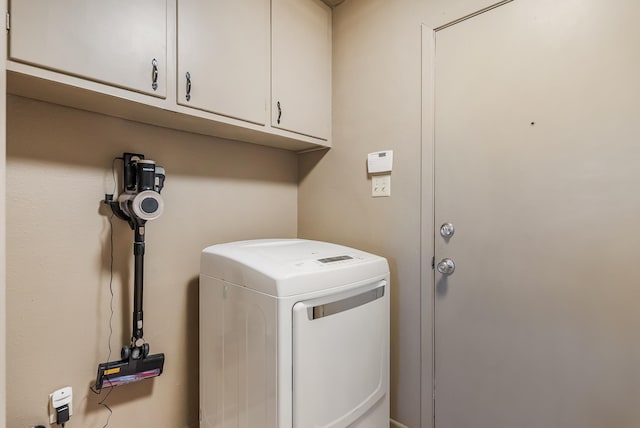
178, 0, 269, 125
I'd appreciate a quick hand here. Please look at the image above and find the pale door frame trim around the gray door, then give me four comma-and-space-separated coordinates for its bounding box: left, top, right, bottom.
420, 0, 515, 428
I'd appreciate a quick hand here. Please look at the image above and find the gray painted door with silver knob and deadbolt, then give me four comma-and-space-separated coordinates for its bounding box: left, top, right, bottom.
434, 0, 640, 428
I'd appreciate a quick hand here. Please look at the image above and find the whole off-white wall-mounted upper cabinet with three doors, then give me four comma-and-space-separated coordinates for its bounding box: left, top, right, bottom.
7, 0, 331, 151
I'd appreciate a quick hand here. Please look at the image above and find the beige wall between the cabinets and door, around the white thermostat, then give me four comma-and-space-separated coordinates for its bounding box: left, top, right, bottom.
298, 0, 495, 428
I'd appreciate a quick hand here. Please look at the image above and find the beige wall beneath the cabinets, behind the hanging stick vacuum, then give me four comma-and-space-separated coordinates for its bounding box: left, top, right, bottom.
7, 96, 297, 428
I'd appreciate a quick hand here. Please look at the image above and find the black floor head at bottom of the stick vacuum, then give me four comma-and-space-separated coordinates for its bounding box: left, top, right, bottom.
96, 354, 164, 390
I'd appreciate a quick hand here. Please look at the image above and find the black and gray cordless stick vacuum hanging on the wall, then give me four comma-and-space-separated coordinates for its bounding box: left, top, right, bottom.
95, 153, 165, 390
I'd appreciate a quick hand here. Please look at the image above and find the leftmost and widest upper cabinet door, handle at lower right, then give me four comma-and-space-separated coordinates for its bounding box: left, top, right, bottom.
9, 0, 167, 97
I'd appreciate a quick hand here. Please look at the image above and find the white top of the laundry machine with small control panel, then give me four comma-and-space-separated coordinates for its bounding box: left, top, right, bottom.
200, 239, 389, 297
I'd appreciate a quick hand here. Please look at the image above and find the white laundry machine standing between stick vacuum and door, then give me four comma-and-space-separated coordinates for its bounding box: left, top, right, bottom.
200, 239, 389, 428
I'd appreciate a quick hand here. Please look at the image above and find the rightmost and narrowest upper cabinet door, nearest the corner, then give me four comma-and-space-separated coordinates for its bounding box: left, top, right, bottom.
271, 0, 331, 140
